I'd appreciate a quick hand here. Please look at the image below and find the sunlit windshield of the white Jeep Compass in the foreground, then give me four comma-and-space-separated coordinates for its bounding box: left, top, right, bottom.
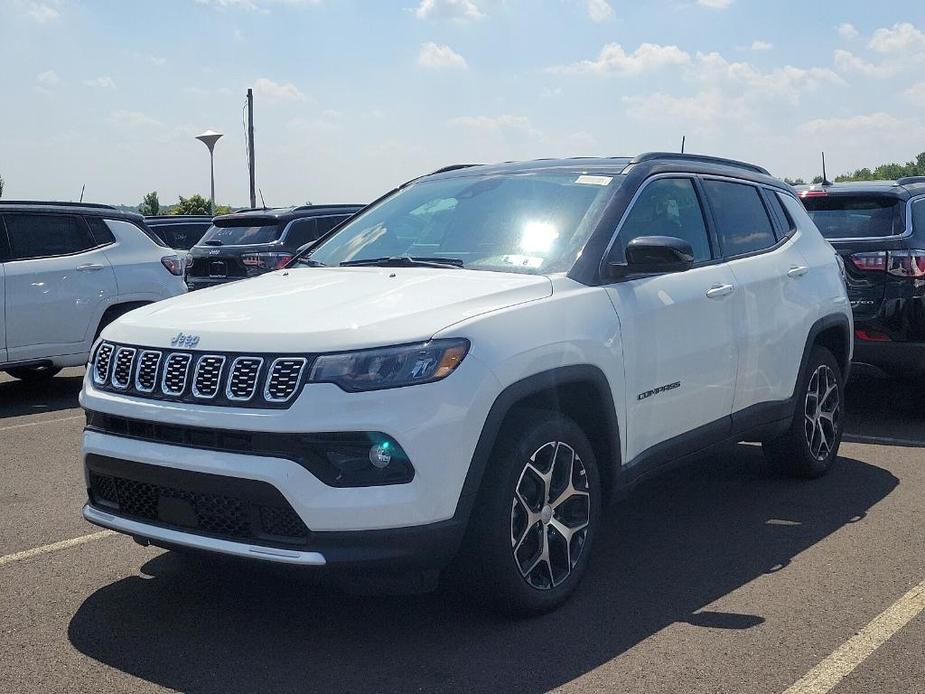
297, 172, 622, 274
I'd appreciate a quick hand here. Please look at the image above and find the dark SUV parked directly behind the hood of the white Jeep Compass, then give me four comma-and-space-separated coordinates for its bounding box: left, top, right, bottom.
186, 205, 363, 290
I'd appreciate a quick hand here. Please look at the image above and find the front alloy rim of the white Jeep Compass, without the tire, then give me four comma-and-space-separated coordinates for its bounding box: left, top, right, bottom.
511, 441, 591, 590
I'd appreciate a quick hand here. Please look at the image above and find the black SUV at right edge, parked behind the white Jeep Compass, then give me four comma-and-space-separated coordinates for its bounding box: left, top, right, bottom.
797, 176, 925, 378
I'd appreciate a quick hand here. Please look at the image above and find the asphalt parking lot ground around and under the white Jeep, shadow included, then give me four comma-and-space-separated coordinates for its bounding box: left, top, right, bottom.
0, 369, 925, 694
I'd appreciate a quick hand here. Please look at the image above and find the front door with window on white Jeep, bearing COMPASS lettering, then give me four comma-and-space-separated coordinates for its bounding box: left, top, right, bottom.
606, 176, 738, 464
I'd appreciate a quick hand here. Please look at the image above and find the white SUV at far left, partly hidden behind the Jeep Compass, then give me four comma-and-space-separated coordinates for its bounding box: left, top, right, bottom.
0, 201, 186, 381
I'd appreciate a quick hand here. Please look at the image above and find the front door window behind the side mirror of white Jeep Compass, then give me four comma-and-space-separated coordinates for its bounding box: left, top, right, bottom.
620, 178, 711, 262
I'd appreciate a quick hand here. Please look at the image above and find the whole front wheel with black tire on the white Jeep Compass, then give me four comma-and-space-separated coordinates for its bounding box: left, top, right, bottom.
462, 410, 602, 616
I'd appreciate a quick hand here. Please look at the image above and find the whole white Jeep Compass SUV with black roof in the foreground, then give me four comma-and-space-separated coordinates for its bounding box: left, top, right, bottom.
81, 153, 852, 613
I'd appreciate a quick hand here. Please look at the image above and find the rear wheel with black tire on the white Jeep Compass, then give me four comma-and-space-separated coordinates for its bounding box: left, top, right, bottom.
763, 347, 845, 478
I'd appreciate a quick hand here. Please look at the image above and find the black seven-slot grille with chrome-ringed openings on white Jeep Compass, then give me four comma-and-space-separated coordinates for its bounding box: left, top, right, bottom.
90, 342, 312, 409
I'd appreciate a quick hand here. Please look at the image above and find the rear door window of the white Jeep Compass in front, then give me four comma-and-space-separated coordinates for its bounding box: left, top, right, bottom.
703, 180, 777, 256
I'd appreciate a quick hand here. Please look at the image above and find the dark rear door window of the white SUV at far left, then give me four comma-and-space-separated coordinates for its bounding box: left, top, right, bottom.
4, 214, 97, 260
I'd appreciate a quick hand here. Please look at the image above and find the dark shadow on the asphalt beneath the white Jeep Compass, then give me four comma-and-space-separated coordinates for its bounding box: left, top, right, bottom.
68, 445, 898, 693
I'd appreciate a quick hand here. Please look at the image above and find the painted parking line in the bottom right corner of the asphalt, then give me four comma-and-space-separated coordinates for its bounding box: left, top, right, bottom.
784, 581, 925, 694
